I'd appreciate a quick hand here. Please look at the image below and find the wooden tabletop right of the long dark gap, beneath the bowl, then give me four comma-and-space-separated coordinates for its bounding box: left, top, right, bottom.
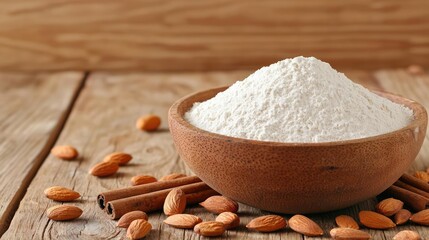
2, 71, 429, 240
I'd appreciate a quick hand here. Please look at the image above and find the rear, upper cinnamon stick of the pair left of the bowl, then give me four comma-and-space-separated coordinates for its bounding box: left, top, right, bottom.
97, 176, 201, 209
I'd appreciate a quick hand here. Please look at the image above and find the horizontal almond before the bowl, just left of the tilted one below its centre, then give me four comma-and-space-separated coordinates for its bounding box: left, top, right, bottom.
246, 215, 287, 232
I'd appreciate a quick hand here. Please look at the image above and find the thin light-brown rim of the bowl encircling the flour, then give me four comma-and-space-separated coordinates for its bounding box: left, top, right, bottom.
168, 86, 428, 147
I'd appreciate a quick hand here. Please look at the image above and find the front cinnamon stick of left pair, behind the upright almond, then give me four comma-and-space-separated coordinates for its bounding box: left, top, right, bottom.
106, 182, 218, 219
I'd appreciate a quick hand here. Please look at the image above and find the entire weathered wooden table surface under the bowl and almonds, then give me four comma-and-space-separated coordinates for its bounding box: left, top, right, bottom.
0, 69, 429, 239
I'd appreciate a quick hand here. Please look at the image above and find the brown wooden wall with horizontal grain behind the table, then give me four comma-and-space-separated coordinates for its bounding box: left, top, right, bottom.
0, 0, 429, 71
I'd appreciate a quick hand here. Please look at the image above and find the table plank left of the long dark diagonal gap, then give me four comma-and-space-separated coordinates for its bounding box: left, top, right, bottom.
0, 72, 83, 235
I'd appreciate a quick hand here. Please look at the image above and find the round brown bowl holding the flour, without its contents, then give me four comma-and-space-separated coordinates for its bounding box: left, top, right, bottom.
169, 87, 427, 213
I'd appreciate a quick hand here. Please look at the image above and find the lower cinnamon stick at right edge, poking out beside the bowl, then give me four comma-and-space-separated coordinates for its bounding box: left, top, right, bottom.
385, 185, 429, 211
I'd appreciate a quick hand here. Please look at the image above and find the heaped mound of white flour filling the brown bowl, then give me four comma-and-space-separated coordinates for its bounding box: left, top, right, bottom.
185, 57, 413, 142
